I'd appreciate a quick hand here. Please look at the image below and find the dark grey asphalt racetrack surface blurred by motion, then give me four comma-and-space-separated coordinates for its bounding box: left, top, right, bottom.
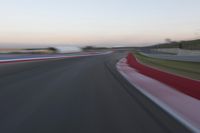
0, 53, 189, 133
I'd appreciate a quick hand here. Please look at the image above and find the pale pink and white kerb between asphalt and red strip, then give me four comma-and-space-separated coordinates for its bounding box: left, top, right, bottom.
117, 58, 200, 132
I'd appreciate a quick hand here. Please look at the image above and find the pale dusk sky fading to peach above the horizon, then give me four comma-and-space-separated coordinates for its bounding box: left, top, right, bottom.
0, 0, 200, 46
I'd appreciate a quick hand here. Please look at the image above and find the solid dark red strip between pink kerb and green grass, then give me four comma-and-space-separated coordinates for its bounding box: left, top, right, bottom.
127, 53, 200, 100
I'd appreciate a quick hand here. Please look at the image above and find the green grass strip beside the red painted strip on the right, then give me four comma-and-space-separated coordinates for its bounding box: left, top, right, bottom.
135, 53, 200, 80
